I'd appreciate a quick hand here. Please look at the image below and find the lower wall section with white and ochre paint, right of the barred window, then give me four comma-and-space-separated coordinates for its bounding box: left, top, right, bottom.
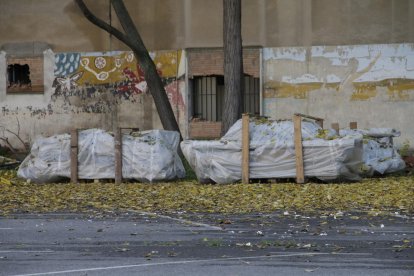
263, 44, 414, 146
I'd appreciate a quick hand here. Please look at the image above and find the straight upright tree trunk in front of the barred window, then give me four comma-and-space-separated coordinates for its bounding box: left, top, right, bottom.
221, 0, 244, 135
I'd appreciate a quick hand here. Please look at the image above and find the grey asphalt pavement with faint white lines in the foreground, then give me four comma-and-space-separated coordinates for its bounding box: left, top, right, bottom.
0, 211, 414, 276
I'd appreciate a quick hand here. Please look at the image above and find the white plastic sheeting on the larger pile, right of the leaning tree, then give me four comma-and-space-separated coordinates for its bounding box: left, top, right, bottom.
181, 120, 403, 183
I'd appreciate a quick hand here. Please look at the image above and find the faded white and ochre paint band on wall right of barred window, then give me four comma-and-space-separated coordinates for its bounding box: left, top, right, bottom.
263, 44, 414, 101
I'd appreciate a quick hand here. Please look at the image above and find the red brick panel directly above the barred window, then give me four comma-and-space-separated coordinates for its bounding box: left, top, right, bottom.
188, 49, 260, 78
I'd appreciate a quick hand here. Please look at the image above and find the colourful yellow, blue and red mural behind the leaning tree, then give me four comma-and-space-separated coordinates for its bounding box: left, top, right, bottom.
52, 51, 184, 113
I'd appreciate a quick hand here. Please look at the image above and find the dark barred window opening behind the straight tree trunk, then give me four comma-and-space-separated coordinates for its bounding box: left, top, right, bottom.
193, 75, 260, 122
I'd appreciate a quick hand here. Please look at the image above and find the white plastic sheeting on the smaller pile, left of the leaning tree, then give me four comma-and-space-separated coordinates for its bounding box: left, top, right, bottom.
17, 129, 185, 183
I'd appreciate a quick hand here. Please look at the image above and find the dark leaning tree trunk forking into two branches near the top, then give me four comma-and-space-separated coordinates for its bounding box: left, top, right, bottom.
75, 0, 182, 140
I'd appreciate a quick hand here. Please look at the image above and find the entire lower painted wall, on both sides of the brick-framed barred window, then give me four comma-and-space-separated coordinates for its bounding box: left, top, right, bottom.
0, 43, 414, 150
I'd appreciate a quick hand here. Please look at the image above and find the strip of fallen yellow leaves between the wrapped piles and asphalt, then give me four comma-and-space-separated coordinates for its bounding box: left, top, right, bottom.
0, 168, 414, 215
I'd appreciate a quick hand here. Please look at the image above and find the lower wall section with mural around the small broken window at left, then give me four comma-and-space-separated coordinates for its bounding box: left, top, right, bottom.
0, 50, 187, 150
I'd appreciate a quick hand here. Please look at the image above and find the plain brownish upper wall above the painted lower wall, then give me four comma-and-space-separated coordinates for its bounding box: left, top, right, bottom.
0, 0, 414, 52
